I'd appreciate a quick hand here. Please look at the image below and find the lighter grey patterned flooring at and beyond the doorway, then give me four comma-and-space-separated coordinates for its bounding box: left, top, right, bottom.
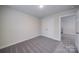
55, 34, 78, 53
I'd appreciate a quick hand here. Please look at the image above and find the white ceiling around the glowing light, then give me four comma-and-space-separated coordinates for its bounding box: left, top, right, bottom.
9, 5, 74, 18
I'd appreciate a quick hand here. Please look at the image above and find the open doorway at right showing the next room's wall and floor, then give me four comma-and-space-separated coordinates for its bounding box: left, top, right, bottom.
61, 15, 77, 52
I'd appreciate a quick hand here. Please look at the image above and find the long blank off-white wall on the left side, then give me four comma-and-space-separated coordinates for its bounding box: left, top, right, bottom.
0, 7, 40, 48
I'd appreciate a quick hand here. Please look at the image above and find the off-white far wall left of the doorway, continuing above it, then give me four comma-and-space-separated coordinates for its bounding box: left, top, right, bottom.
41, 9, 76, 41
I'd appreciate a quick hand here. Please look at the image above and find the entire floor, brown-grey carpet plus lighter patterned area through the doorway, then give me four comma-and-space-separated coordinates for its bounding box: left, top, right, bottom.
0, 35, 77, 53
